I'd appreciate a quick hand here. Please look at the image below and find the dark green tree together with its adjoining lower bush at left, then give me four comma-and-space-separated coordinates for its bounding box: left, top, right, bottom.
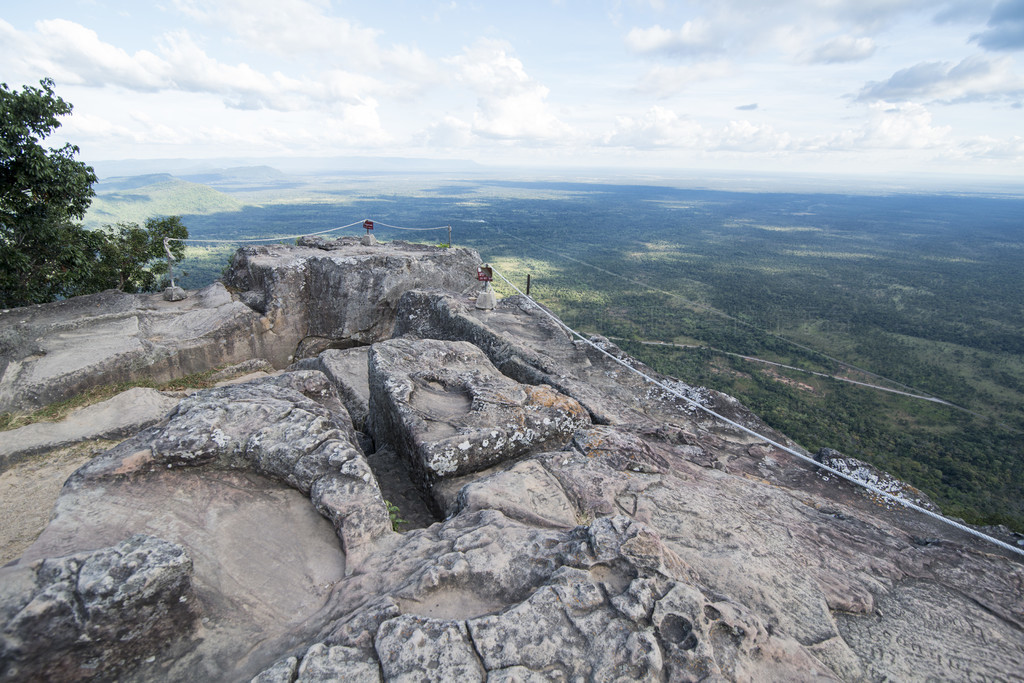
0, 79, 188, 308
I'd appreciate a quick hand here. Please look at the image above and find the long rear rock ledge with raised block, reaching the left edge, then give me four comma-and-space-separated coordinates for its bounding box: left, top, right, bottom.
0, 238, 479, 412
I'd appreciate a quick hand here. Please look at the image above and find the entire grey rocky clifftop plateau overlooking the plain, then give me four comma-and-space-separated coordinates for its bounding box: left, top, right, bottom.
0, 239, 1024, 683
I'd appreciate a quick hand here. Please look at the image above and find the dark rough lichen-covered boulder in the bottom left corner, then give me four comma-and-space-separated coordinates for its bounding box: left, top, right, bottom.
0, 535, 199, 681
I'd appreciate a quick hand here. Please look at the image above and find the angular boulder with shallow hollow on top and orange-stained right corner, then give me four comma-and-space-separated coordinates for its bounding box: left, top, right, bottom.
370, 339, 590, 482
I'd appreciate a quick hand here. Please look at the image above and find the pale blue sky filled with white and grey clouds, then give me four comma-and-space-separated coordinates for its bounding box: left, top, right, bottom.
0, 0, 1024, 177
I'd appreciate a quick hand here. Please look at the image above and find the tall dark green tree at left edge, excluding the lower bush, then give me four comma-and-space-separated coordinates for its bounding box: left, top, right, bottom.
0, 79, 96, 307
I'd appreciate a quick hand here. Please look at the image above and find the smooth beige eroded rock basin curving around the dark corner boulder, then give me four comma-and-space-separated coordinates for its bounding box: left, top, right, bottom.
20, 470, 345, 680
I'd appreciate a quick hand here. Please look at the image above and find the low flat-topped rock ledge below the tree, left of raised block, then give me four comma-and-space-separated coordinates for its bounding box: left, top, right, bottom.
0, 283, 275, 411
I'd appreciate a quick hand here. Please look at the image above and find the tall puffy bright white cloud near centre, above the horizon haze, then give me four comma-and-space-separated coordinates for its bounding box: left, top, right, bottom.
447, 39, 572, 141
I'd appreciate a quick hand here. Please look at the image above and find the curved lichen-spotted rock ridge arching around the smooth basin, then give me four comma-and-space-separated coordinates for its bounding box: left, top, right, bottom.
70, 371, 390, 562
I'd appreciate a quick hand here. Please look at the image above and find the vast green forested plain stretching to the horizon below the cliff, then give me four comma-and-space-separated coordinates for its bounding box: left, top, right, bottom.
86, 167, 1024, 531
